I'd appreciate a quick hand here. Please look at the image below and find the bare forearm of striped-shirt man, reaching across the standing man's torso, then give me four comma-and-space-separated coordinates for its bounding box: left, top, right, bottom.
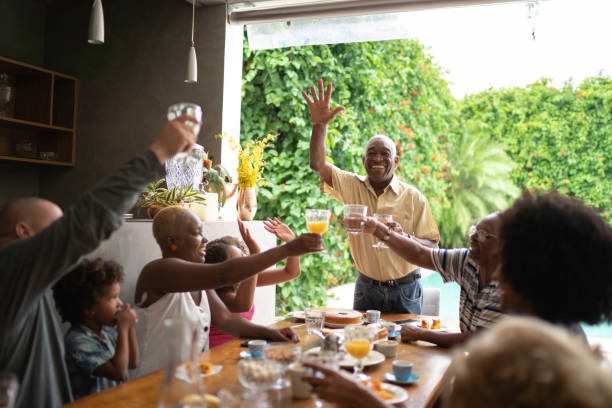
364, 217, 435, 270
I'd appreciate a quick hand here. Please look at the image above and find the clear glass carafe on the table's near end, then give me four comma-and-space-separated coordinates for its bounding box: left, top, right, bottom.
157, 319, 206, 408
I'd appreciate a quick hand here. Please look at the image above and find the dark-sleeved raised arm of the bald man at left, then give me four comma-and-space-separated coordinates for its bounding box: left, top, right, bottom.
0, 116, 196, 337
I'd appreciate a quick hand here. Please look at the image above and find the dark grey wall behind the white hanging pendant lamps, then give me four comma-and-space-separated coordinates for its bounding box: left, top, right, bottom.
40, 0, 225, 207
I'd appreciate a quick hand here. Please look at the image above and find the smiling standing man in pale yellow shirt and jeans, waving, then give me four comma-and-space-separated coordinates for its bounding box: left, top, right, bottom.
302, 79, 440, 314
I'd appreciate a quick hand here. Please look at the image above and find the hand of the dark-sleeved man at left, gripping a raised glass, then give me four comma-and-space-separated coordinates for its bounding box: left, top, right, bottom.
150, 115, 198, 163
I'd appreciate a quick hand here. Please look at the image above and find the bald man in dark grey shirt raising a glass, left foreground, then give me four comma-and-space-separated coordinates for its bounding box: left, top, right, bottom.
0, 116, 195, 408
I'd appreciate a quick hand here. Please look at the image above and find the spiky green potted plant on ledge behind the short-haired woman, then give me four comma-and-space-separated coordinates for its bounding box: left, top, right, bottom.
136, 179, 206, 218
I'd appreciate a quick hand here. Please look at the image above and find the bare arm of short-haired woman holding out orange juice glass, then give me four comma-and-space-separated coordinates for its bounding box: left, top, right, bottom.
136, 233, 322, 305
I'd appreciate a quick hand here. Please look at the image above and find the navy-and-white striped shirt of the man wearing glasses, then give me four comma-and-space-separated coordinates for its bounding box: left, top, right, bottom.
431, 248, 503, 332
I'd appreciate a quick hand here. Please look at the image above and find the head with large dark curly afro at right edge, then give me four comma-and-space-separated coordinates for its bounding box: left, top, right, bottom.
500, 192, 612, 333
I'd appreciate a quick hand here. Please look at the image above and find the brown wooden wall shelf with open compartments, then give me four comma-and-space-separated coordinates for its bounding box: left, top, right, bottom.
0, 57, 78, 166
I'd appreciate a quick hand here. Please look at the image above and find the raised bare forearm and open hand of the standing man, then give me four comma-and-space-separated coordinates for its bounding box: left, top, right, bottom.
302, 79, 344, 186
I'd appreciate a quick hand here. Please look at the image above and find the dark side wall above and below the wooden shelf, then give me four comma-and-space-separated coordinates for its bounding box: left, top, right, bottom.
0, 0, 45, 205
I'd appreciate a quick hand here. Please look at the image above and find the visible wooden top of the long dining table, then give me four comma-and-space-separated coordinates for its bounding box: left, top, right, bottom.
66, 314, 458, 408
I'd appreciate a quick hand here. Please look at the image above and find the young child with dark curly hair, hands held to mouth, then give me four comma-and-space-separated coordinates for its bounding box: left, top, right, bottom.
53, 258, 138, 399
